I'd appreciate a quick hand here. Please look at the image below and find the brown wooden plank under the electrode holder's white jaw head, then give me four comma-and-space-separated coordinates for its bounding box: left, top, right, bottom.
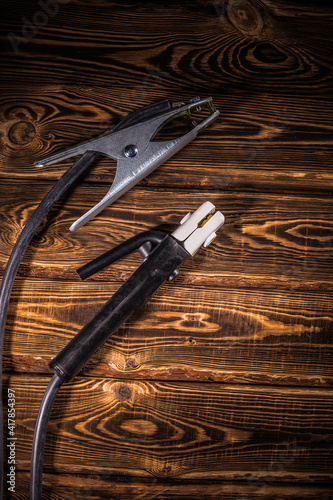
0, 180, 333, 289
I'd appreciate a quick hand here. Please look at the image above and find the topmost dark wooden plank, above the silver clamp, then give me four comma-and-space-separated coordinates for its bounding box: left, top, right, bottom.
1, 0, 332, 94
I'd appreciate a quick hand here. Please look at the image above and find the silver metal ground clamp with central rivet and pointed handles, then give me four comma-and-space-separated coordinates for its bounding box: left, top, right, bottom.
35, 97, 219, 231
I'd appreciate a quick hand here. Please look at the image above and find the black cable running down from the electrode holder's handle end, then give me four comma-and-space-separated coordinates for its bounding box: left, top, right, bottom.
30, 374, 62, 500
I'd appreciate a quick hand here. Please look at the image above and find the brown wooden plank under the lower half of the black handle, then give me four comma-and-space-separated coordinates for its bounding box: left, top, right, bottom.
4, 279, 333, 386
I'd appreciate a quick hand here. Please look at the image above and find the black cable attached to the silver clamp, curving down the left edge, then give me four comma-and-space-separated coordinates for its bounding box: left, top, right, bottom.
0, 151, 99, 499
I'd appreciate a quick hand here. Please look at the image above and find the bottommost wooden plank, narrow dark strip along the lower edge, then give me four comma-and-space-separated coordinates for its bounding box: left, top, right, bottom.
10, 471, 333, 500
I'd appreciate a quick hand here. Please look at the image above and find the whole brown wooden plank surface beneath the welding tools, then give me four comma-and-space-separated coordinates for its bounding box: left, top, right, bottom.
0, 0, 333, 500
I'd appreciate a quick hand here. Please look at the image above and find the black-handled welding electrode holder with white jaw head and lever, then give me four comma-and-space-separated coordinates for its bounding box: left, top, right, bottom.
49, 202, 224, 382
